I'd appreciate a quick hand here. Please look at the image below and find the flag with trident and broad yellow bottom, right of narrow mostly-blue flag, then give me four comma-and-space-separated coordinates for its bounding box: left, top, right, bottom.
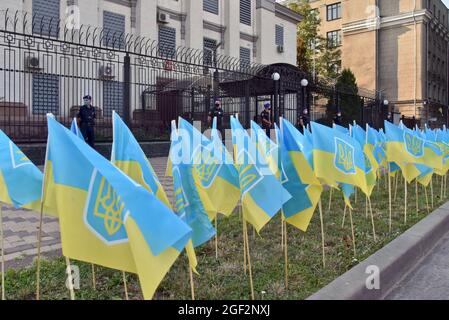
179, 118, 240, 220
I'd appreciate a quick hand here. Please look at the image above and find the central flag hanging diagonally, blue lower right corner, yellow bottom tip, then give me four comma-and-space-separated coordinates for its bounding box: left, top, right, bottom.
231, 117, 291, 232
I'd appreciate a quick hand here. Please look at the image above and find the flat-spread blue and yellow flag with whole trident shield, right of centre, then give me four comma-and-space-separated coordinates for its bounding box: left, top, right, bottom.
312, 122, 369, 195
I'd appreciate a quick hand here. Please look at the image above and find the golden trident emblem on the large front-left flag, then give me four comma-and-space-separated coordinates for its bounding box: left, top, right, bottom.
94, 178, 125, 236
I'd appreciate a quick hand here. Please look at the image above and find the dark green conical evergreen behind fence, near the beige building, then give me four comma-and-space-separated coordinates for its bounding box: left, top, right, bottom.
326, 69, 361, 125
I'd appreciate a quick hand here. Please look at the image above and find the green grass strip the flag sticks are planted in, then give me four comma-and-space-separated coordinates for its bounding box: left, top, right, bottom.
6, 172, 445, 300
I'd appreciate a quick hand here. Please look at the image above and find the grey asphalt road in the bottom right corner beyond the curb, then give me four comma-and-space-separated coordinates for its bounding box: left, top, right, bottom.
385, 233, 449, 300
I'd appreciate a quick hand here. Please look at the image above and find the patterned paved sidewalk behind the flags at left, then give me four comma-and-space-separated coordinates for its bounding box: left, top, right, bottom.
2, 158, 173, 269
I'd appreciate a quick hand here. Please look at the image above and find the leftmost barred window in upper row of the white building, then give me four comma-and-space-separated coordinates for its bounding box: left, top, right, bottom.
33, 0, 60, 38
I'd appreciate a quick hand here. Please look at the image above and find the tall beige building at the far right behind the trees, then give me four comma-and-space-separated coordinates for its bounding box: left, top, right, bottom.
304, 0, 449, 122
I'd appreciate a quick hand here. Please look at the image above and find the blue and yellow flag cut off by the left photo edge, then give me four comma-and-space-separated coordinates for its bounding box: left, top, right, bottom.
0, 130, 43, 210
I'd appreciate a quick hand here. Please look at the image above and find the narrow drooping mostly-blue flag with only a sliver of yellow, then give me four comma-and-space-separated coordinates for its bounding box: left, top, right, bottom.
170, 120, 216, 247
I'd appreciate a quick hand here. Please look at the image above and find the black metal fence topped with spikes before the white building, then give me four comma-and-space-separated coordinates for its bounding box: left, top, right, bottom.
0, 10, 384, 142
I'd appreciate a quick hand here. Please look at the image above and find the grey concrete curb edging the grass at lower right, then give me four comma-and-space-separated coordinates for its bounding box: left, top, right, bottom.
307, 202, 449, 300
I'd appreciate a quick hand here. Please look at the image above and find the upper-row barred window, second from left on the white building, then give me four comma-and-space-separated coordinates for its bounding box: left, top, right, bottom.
103, 11, 125, 49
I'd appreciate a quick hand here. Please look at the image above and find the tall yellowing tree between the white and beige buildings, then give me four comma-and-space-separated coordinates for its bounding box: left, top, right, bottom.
288, 0, 341, 82
